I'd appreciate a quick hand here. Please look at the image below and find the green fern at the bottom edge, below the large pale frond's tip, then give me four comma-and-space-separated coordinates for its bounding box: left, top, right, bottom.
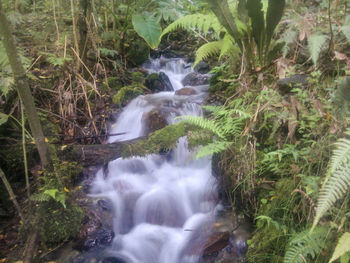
283, 227, 327, 263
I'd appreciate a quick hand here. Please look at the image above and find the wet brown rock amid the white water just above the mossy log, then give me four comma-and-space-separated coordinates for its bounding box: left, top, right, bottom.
142, 109, 167, 135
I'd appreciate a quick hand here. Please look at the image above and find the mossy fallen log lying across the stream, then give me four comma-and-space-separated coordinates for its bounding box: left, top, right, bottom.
59, 124, 188, 166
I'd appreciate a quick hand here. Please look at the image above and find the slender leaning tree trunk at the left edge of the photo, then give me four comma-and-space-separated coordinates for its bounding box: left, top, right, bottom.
0, 1, 50, 168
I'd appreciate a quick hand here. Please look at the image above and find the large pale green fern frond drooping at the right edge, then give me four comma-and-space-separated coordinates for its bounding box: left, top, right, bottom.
313, 129, 350, 228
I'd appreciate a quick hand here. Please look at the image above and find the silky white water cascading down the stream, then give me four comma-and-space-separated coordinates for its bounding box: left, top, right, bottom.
91, 58, 217, 263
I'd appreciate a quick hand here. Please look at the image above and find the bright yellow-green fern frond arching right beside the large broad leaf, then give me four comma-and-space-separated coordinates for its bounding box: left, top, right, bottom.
160, 14, 224, 38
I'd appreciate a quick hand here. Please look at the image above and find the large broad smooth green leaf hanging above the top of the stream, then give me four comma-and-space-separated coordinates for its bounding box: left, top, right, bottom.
132, 13, 162, 49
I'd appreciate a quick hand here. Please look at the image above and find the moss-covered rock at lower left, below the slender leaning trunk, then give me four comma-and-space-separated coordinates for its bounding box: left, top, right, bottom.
41, 200, 84, 244
